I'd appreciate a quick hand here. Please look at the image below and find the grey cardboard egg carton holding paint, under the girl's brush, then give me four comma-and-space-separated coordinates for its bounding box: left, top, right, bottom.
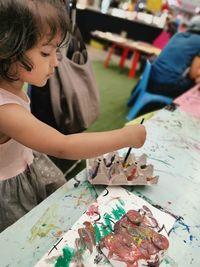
87, 152, 158, 185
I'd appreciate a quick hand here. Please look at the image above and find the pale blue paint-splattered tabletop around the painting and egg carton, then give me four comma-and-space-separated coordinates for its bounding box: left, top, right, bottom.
0, 109, 200, 267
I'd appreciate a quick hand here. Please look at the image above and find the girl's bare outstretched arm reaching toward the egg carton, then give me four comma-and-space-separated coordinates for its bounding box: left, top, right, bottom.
0, 104, 146, 159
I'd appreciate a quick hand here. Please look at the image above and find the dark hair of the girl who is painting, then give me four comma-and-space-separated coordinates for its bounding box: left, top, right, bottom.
0, 0, 70, 81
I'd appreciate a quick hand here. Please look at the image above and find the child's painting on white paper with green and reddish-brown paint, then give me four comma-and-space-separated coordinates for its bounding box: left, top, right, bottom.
36, 187, 175, 267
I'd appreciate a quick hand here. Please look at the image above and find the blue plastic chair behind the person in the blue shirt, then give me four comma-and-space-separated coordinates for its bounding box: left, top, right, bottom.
127, 60, 173, 121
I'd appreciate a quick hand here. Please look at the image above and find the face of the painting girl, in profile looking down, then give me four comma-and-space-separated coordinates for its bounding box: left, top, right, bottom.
16, 36, 60, 87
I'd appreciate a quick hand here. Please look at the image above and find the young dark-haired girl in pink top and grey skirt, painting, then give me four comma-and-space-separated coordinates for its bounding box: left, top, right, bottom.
0, 0, 146, 231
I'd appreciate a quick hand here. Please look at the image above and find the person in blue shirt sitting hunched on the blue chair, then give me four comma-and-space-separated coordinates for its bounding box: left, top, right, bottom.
148, 16, 200, 98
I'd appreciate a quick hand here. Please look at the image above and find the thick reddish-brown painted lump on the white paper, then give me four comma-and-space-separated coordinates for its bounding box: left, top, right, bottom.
100, 207, 169, 267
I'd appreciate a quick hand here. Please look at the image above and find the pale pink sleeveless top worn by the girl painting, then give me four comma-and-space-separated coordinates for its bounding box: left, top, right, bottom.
0, 88, 33, 180
